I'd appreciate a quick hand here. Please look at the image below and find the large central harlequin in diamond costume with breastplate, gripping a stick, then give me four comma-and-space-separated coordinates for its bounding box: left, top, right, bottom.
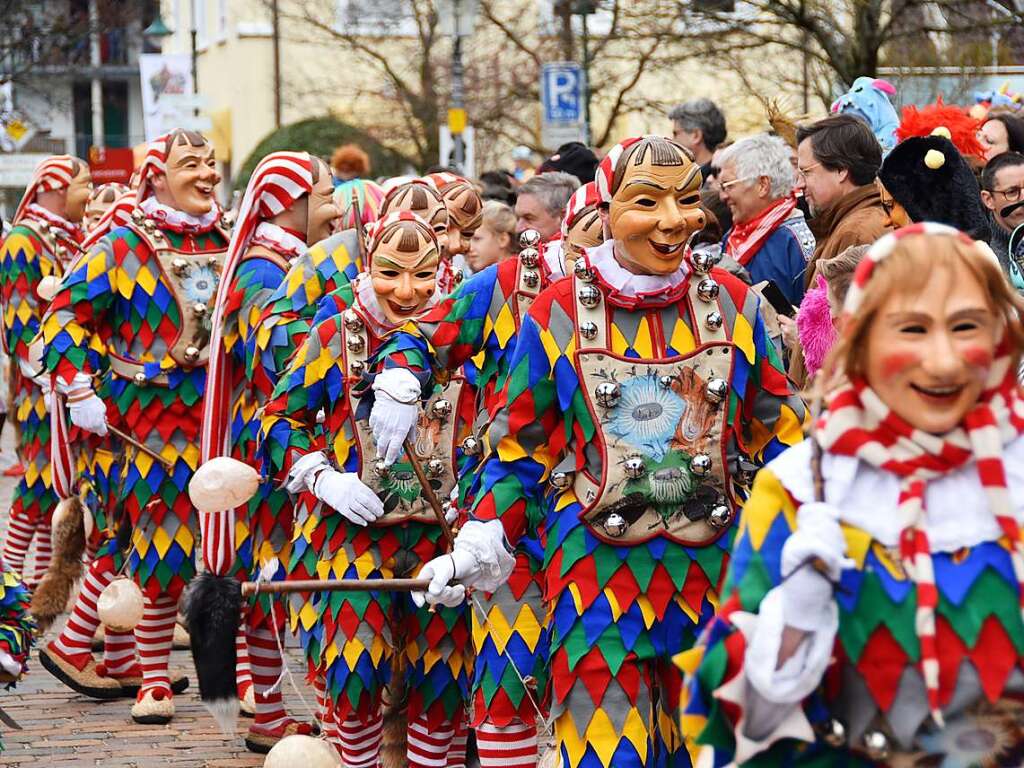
409, 137, 803, 768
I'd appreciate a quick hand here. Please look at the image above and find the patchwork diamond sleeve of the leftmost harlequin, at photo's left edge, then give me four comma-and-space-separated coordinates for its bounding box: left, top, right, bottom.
0, 226, 52, 360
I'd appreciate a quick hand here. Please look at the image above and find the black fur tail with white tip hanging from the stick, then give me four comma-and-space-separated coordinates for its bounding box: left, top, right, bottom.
183, 571, 242, 735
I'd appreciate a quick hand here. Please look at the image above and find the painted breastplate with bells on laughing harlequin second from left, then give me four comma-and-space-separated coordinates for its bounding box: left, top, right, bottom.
131, 210, 228, 369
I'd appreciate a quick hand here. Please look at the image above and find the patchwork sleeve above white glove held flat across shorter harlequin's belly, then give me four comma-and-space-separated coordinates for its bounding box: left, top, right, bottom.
263, 316, 355, 481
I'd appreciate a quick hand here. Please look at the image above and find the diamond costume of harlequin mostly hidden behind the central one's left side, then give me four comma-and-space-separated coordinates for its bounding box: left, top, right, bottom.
375, 241, 565, 741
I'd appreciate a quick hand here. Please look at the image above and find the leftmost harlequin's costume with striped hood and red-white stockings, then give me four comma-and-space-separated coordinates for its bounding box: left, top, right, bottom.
0, 155, 88, 583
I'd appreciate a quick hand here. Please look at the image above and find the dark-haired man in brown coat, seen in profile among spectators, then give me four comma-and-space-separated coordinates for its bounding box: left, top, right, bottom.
790, 115, 891, 387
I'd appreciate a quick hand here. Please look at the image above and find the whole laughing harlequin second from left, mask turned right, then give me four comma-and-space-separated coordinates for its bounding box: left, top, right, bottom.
37, 131, 227, 723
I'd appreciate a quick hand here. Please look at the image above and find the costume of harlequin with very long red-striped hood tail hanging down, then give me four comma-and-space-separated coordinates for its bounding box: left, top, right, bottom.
189, 152, 327, 753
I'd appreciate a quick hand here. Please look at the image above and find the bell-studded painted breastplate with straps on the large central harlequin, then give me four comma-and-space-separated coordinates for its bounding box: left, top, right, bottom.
551, 262, 734, 546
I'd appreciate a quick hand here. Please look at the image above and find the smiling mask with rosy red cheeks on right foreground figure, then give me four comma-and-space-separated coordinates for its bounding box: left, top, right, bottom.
864, 264, 1001, 434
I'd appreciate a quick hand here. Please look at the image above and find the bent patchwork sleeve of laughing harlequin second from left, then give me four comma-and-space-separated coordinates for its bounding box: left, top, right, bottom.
42, 236, 117, 382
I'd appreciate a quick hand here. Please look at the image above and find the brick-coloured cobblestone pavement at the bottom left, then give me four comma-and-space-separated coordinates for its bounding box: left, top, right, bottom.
0, 436, 315, 768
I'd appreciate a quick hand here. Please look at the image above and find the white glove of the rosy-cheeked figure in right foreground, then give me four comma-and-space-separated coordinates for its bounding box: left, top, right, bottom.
781, 502, 852, 632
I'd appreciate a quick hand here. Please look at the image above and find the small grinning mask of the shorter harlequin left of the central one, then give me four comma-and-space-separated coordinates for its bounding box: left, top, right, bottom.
370, 221, 440, 326
